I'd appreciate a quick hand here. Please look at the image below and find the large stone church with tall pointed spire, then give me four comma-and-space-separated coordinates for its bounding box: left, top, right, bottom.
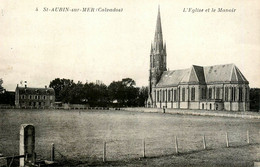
146, 9, 249, 111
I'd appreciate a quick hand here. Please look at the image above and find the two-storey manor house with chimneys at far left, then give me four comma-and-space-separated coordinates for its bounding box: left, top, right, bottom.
15, 84, 55, 108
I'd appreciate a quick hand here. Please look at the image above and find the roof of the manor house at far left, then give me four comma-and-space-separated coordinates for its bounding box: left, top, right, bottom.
16, 87, 55, 95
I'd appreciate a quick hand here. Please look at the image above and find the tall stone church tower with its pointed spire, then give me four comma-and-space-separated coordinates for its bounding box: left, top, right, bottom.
147, 7, 167, 107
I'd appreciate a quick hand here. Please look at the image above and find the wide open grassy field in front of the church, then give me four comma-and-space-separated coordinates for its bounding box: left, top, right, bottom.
0, 110, 260, 166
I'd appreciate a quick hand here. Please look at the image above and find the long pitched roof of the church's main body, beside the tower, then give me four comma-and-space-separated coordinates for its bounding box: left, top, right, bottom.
156, 64, 248, 87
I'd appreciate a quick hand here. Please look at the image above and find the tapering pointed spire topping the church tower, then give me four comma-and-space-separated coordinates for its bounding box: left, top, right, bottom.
154, 6, 163, 51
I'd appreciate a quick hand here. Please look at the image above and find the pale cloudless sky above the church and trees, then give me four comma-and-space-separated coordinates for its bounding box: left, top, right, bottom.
0, 0, 260, 91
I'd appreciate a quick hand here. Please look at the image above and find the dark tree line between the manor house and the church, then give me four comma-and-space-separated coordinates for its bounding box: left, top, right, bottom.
49, 78, 148, 107
